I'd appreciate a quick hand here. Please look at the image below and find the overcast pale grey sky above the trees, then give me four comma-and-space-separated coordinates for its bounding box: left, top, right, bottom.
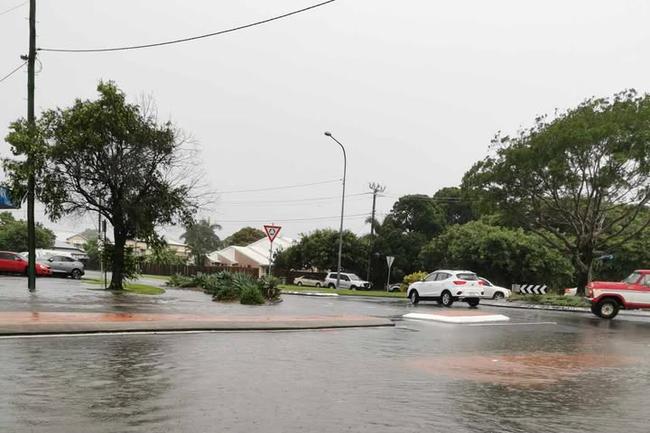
0, 0, 650, 237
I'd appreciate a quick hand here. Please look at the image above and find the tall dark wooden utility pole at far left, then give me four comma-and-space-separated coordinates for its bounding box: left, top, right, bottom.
27, 0, 36, 292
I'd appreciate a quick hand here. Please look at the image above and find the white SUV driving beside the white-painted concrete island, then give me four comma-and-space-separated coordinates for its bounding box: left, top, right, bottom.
407, 270, 484, 307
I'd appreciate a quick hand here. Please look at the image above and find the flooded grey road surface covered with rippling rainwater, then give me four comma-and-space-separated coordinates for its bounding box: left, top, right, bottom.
0, 277, 650, 433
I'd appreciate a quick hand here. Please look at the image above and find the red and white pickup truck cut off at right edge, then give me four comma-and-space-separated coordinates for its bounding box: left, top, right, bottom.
587, 269, 650, 319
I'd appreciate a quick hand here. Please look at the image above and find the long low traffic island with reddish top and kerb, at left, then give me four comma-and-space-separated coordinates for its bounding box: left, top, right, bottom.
0, 312, 394, 336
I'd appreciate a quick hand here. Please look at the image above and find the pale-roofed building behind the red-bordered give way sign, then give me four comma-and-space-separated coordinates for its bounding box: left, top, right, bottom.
208, 236, 296, 276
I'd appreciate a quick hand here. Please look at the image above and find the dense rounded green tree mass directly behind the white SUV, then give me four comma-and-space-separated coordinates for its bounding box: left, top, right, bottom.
420, 221, 573, 289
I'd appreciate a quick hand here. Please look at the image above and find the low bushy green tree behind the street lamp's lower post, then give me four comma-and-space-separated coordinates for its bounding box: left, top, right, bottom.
274, 229, 368, 275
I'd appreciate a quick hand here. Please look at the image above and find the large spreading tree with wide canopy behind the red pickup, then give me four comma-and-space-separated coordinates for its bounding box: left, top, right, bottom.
464, 91, 650, 295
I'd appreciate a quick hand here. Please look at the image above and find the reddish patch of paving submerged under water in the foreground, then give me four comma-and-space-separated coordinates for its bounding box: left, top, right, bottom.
408, 352, 639, 386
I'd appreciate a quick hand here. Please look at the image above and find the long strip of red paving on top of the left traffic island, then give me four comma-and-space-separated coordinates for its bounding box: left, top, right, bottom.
0, 311, 368, 325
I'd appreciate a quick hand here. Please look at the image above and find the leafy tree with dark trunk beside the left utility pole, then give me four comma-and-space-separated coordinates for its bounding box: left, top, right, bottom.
5, 82, 198, 290
